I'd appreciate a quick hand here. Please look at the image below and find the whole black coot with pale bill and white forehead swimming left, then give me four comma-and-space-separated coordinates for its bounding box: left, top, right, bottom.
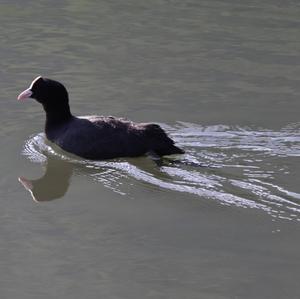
18, 76, 184, 160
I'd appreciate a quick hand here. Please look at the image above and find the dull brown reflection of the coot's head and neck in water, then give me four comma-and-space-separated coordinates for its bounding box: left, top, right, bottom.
19, 156, 73, 202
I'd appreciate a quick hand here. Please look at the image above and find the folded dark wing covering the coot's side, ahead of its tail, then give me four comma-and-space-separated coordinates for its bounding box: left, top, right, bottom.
57, 116, 146, 159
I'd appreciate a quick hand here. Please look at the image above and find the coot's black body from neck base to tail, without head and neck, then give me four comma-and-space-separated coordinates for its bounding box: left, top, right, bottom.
46, 116, 183, 160
